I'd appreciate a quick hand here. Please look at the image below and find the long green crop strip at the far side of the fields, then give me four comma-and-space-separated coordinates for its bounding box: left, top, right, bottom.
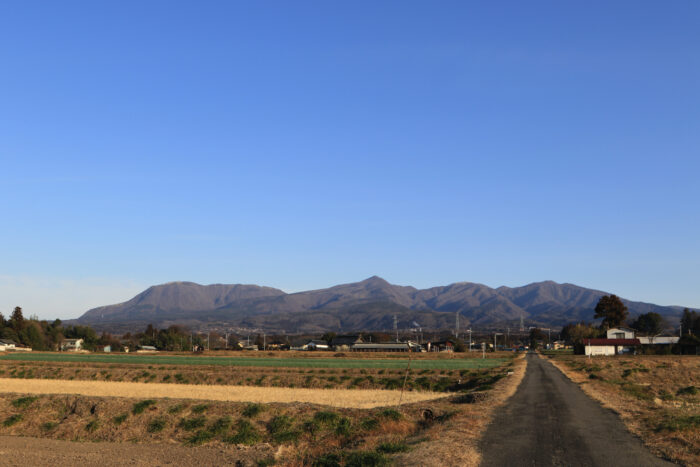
0, 352, 507, 370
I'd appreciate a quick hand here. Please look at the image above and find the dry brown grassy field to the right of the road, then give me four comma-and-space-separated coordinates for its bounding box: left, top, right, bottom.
551, 355, 700, 466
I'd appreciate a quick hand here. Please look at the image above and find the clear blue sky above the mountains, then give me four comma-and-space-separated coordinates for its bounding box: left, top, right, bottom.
0, 0, 700, 318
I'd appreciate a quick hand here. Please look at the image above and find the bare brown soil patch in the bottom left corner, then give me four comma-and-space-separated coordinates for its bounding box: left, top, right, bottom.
0, 436, 273, 467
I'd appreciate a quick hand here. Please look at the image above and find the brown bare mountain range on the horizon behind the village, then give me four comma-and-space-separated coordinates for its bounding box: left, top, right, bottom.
75, 276, 682, 333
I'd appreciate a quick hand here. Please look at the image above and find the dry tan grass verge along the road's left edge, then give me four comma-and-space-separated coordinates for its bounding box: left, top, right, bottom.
396, 354, 527, 467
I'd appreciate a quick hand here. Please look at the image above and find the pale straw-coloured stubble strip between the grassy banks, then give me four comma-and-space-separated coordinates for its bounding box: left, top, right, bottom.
0, 378, 445, 409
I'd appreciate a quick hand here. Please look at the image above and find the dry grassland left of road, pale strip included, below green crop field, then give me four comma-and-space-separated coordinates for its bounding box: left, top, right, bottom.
0, 355, 524, 466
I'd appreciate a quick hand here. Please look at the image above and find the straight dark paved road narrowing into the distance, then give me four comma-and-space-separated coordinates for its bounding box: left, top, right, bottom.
481, 353, 673, 467
